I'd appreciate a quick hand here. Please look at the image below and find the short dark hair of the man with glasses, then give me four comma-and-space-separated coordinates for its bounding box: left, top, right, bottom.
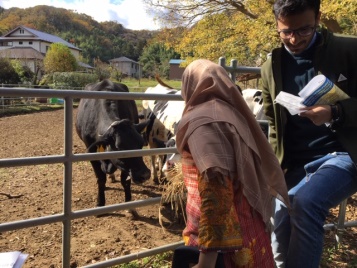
273, 0, 320, 19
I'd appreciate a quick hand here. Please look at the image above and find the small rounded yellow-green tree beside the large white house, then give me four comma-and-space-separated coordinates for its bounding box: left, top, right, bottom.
43, 43, 78, 73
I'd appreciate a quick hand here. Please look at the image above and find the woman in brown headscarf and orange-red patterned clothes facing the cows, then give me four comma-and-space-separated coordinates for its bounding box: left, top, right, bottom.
177, 60, 288, 268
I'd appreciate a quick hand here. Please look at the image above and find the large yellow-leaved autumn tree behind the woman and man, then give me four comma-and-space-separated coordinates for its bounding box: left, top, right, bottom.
151, 0, 357, 66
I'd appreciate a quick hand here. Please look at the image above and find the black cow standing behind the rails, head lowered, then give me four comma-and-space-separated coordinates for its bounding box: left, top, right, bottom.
76, 80, 150, 206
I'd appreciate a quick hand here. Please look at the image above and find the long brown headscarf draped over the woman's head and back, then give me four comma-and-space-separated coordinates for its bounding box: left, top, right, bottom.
176, 60, 288, 222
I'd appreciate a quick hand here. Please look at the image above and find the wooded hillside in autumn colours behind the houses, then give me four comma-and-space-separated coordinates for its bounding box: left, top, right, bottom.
0, 5, 157, 64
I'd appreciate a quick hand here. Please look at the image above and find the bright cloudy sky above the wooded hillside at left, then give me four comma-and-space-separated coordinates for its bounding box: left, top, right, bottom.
0, 0, 160, 30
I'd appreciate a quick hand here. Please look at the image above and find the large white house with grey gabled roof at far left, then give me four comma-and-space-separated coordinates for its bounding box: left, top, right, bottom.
0, 26, 92, 76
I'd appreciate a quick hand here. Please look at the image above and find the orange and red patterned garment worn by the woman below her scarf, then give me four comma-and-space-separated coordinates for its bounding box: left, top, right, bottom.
182, 154, 274, 268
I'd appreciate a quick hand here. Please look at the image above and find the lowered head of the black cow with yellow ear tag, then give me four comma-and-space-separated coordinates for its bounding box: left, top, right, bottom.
87, 119, 150, 183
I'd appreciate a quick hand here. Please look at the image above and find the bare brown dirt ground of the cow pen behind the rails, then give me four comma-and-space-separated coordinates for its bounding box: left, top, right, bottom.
0, 110, 357, 268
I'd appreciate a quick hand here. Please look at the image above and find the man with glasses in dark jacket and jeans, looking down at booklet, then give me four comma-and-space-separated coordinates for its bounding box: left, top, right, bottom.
261, 0, 357, 268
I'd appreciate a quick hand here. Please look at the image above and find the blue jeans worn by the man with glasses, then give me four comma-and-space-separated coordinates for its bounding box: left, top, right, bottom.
272, 153, 357, 268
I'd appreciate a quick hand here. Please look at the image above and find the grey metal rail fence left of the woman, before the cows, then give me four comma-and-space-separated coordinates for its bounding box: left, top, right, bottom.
0, 88, 183, 267
